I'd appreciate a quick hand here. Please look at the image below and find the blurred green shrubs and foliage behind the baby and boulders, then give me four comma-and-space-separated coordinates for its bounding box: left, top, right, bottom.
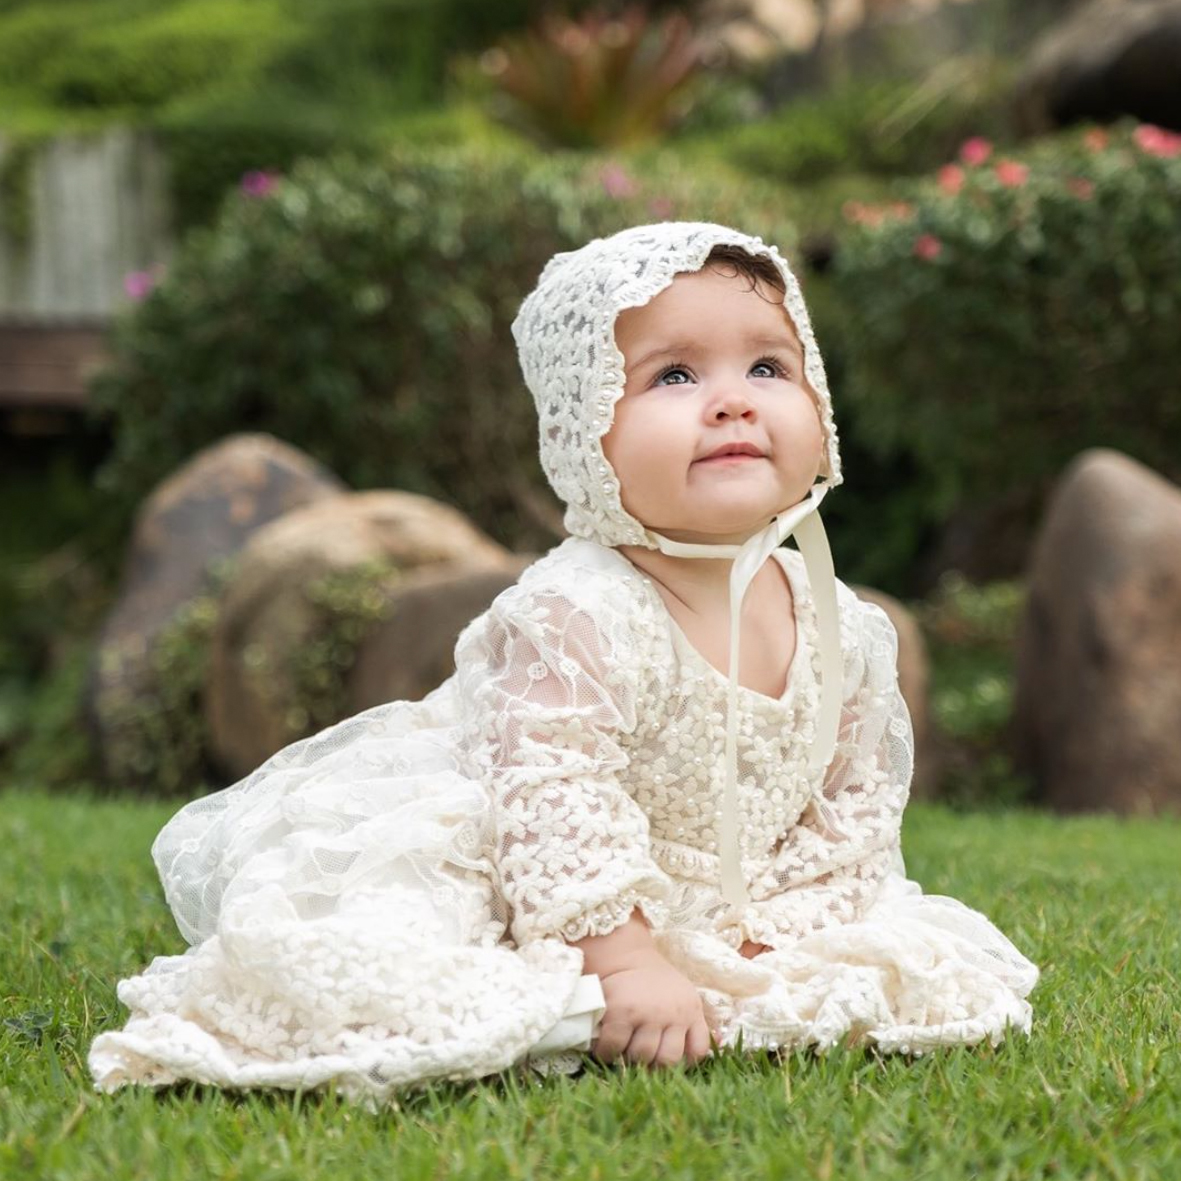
0, 0, 1181, 802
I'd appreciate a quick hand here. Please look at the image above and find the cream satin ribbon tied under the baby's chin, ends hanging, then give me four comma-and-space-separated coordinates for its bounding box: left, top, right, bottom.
648, 484, 843, 911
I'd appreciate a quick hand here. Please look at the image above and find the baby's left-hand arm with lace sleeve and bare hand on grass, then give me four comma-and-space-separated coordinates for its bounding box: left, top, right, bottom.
456, 588, 710, 1065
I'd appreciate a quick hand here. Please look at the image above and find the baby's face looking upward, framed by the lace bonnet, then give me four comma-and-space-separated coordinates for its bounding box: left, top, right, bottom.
602, 267, 824, 542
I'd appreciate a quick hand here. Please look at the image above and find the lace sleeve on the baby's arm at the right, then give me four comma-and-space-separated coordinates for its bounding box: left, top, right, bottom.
742, 587, 914, 946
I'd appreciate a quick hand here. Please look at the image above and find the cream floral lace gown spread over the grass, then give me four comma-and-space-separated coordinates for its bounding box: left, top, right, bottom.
90, 537, 1038, 1101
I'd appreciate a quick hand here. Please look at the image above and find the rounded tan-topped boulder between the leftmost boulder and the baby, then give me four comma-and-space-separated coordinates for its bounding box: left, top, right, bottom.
204, 491, 516, 778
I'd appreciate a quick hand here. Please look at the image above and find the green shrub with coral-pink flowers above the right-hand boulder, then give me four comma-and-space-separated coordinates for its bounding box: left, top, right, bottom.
831, 117, 1181, 533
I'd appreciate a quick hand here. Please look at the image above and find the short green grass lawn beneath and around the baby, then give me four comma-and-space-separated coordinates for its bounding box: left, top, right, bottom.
0, 791, 1181, 1181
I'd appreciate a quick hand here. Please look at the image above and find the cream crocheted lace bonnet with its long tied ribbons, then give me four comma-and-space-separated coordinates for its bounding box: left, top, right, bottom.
513, 222, 842, 905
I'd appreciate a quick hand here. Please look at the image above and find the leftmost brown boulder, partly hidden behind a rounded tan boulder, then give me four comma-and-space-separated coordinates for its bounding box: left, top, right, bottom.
86, 435, 344, 787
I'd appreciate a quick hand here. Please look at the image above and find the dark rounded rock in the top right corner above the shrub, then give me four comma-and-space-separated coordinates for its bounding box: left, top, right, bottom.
1016, 0, 1181, 133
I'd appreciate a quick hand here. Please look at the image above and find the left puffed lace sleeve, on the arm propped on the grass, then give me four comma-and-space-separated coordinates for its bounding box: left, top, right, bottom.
456, 576, 672, 944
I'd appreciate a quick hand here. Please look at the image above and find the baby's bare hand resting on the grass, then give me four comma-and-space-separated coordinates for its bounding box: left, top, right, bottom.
591, 952, 712, 1066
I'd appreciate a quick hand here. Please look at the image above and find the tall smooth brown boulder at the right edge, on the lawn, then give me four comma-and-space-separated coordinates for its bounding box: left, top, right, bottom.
1013, 450, 1181, 814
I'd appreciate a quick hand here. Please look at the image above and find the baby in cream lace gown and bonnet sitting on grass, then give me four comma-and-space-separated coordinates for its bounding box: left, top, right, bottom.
91, 222, 1038, 1101
